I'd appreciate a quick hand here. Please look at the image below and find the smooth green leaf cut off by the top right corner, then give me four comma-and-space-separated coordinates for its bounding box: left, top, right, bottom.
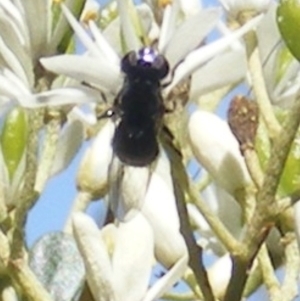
277, 0, 300, 61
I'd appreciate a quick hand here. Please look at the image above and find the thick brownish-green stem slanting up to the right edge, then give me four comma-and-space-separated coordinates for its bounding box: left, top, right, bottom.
224, 94, 300, 301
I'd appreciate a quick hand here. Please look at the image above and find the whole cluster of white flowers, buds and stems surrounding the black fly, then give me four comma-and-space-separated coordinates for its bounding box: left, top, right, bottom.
0, 0, 300, 301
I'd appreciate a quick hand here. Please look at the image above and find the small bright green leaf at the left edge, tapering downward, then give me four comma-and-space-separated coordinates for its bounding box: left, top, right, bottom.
1, 107, 28, 181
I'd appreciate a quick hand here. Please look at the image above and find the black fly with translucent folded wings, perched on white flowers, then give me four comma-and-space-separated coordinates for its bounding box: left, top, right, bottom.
95, 47, 169, 221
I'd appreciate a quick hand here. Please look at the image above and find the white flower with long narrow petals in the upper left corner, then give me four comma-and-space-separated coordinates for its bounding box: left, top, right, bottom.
0, 0, 95, 108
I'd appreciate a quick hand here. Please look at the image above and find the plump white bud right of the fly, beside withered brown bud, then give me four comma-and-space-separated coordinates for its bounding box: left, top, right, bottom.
188, 111, 250, 194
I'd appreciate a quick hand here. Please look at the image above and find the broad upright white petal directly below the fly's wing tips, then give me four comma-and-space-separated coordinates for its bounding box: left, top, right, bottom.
112, 213, 154, 301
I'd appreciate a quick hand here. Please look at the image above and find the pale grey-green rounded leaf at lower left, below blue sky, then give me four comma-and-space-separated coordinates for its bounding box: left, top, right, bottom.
29, 232, 85, 301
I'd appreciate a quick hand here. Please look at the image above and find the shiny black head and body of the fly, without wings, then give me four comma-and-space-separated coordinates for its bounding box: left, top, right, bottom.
112, 48, 169, 166
